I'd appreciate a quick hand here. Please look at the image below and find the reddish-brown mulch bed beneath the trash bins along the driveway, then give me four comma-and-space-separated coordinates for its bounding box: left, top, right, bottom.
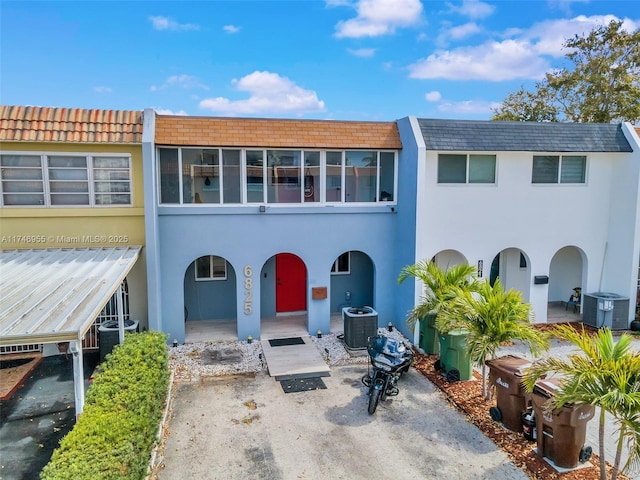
414, 346, 628, 480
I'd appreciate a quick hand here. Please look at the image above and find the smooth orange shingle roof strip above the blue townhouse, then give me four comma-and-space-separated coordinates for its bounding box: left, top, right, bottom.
155, 115, 402, 149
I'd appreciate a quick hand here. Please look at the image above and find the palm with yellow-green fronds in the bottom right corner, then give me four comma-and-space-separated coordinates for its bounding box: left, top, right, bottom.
523, 325, 640, 480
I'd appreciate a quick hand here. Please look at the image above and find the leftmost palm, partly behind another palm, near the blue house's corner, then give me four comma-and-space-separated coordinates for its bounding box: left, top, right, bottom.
398, 260, 476, 329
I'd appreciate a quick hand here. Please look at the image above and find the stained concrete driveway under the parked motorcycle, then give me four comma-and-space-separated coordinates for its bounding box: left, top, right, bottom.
158, 365, 527, 480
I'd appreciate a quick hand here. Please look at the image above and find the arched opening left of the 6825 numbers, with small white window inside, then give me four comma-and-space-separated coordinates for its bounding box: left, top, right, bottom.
184, 255, 238, 342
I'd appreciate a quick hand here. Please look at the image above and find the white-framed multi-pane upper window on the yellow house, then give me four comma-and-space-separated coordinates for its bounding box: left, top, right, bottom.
0, 153, 131, 207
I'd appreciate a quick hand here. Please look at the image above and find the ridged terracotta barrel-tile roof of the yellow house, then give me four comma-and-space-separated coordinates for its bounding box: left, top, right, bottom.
0, 105, 142, 143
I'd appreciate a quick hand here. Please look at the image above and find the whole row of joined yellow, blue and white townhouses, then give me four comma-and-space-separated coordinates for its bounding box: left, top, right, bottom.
0, 107, 640, 342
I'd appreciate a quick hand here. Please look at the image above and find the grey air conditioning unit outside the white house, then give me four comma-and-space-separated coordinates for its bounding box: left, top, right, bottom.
582, 292, 629, 330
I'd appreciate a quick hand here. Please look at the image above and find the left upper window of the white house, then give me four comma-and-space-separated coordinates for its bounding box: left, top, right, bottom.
438, 153, 496, 183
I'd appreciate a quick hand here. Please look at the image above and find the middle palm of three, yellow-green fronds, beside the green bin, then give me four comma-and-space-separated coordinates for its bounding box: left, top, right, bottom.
436, 279, 547, 399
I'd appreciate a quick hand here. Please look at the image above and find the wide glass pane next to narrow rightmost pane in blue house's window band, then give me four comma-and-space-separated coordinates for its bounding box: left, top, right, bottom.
345, 151, 378, 202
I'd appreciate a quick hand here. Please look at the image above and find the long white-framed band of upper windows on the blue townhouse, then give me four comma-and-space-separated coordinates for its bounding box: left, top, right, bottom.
158, 147, 396, 205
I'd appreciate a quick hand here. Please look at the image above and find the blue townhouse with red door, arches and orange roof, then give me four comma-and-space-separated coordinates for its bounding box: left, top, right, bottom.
143, 111, 402, 342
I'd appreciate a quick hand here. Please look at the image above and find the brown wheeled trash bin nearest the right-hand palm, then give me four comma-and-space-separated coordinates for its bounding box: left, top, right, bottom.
527, 379, 595, 468
